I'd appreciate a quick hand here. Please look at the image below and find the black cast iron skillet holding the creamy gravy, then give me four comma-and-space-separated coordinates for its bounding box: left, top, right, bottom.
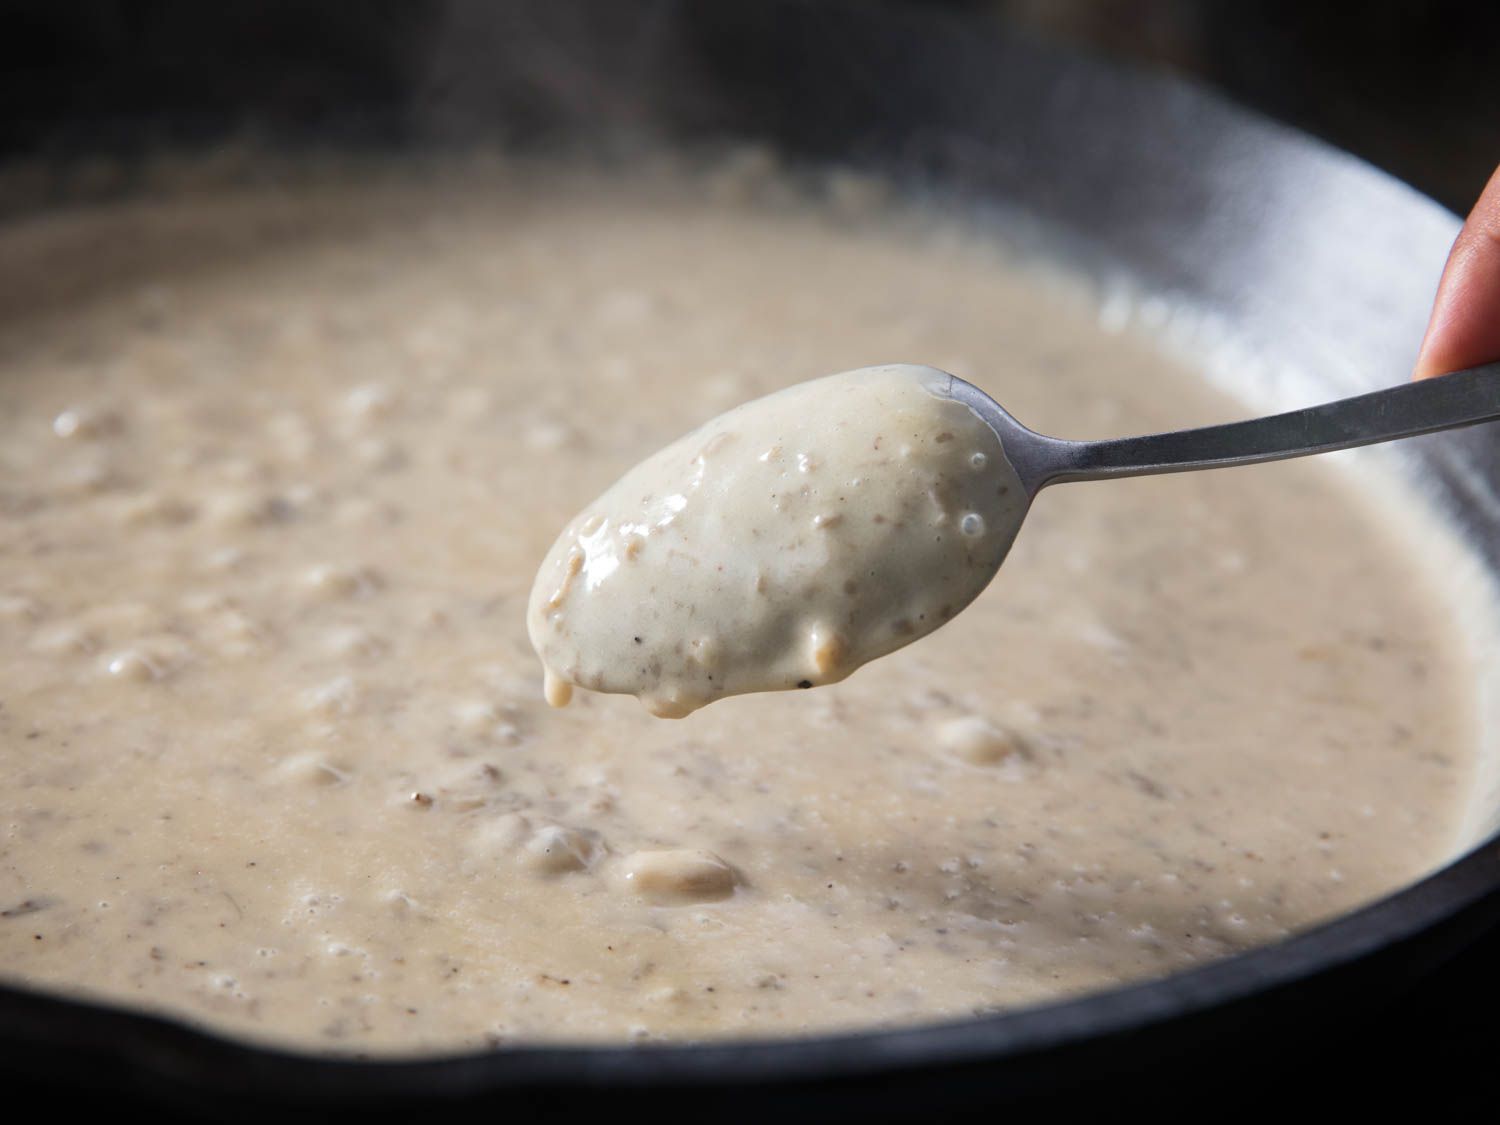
0, 0, 1500, 1119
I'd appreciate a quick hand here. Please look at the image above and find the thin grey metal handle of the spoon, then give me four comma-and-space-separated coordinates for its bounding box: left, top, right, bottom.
1031, 363, 1500, 489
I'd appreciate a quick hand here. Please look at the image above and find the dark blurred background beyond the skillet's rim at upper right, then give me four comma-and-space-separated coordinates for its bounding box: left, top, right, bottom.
966, 0, 1500, 215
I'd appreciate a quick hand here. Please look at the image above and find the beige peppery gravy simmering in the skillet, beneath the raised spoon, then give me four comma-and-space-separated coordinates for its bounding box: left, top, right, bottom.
0, 162, 1475, 1053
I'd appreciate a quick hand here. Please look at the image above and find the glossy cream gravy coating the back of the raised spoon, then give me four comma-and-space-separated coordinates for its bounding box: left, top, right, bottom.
528, 365, 1026, 719
